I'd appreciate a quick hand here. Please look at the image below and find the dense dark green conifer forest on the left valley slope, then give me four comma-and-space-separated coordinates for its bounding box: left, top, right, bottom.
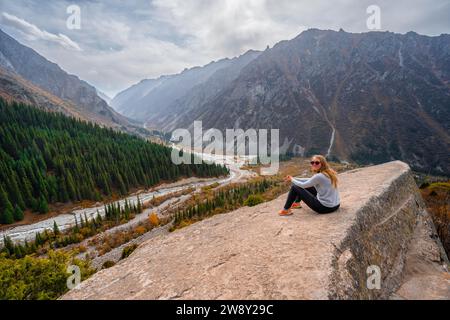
0, 98, 228, 224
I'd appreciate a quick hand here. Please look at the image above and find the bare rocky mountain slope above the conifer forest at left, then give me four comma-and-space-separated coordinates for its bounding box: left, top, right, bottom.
0, 30, 141, 132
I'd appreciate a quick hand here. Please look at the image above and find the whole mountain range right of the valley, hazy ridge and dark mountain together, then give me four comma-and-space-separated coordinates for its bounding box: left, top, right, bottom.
111, 29, 450, 174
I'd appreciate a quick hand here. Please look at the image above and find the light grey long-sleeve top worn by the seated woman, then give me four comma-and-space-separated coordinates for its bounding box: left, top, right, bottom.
292, 172, 341, 208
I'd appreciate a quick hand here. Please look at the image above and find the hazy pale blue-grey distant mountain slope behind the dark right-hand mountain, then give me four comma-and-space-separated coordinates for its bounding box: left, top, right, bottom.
111, 50, 260, 127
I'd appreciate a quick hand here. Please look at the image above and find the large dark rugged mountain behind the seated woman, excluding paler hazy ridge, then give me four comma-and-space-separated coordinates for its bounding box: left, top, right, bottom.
183, 30, 450, 172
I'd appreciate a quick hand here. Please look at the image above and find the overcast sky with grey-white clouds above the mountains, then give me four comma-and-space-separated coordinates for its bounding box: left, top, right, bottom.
0, 0, 450, 96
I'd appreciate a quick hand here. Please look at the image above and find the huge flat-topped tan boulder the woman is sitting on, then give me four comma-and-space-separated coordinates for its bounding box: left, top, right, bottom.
63, 161, 448, 299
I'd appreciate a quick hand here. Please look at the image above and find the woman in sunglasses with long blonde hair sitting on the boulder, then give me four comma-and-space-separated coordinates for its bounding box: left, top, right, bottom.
279, 155, 340, 216
